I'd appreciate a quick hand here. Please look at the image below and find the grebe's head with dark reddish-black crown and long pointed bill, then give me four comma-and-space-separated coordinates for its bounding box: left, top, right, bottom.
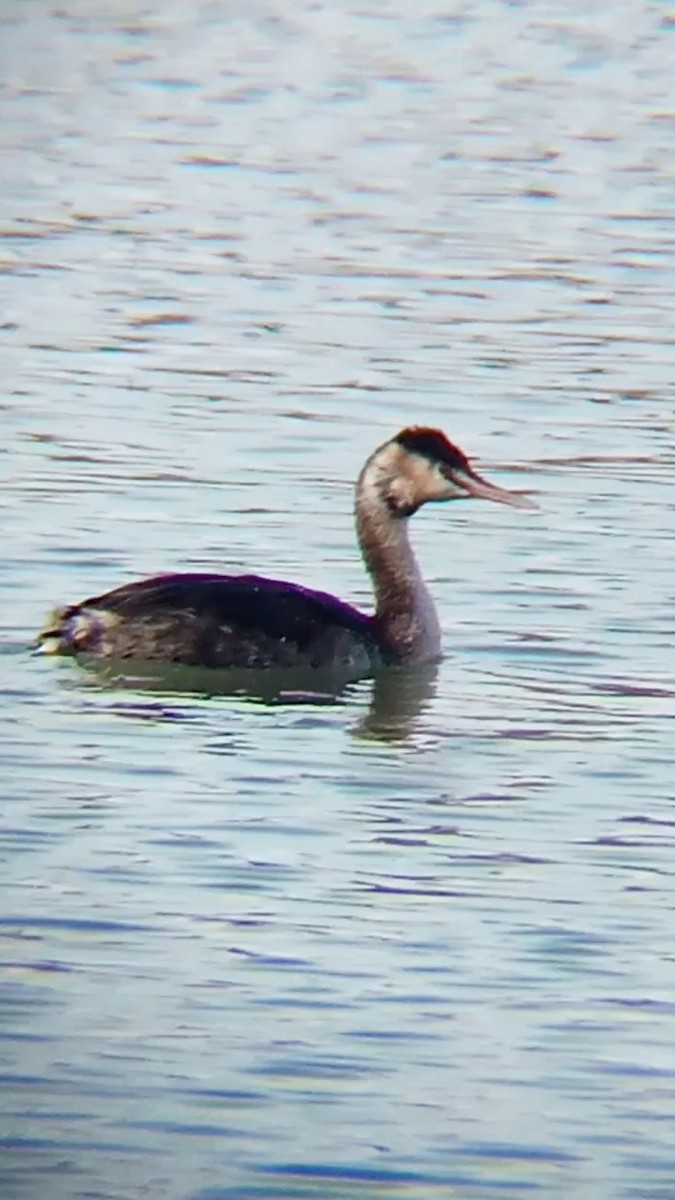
359, 425, 537, 517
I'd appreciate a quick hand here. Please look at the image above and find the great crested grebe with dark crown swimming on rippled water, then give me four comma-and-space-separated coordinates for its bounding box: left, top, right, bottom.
37, 426, 536, 676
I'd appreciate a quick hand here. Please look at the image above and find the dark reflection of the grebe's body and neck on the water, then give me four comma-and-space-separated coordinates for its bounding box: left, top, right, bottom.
69, 660, 438, 742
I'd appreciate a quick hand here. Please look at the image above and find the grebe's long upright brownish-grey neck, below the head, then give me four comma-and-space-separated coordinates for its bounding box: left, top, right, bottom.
354, 461, 441, 661
